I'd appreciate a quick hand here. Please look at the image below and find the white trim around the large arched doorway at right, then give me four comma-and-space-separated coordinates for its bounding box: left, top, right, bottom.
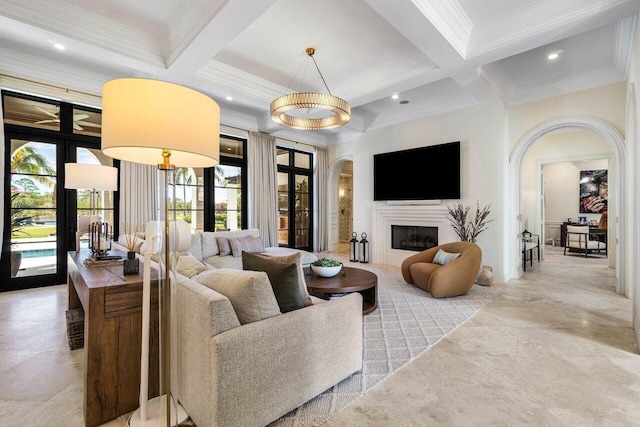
506, 116, 626, 295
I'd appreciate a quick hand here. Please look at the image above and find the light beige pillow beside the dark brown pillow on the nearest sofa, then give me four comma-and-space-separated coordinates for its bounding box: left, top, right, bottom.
194, 268, 281, 325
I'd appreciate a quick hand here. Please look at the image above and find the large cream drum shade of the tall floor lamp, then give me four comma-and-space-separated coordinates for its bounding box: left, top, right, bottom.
102, 79, 220, 167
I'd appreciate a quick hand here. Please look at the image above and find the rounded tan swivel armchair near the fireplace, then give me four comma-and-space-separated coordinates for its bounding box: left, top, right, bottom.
402, 242, 482, 298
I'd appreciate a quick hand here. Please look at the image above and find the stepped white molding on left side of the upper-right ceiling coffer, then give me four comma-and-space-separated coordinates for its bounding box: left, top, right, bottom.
412, 0, 474, 58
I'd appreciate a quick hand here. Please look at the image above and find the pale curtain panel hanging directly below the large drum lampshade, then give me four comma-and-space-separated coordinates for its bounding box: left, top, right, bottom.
120, 161, 159, 234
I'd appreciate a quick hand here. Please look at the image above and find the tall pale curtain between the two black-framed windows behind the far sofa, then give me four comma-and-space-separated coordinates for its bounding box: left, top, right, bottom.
248, 132, 278, 247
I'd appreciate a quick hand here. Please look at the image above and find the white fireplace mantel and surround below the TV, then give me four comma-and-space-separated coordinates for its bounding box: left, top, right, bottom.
370, 205, 458, 267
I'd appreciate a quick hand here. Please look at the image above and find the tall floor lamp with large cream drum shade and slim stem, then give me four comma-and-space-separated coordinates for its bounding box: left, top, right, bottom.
102, 78, 220, 426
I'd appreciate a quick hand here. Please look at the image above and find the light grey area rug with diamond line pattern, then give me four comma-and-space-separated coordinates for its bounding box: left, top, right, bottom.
118, 265, 499, 427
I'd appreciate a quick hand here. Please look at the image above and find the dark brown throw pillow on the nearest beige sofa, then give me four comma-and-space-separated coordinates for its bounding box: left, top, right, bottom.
242, 252, 307, 313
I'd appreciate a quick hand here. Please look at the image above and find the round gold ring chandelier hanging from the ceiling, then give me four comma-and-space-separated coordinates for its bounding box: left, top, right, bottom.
270, 47, 351, 130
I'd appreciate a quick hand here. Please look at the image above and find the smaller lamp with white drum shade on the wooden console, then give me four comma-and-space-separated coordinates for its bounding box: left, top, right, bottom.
64, 163, 118, 254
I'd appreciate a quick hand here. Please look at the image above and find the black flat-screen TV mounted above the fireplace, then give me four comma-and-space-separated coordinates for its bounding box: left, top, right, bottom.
373, 141, 460, 200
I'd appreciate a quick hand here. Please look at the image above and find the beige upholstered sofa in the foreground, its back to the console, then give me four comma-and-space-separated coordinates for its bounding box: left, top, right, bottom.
175, 269, 363, 427
